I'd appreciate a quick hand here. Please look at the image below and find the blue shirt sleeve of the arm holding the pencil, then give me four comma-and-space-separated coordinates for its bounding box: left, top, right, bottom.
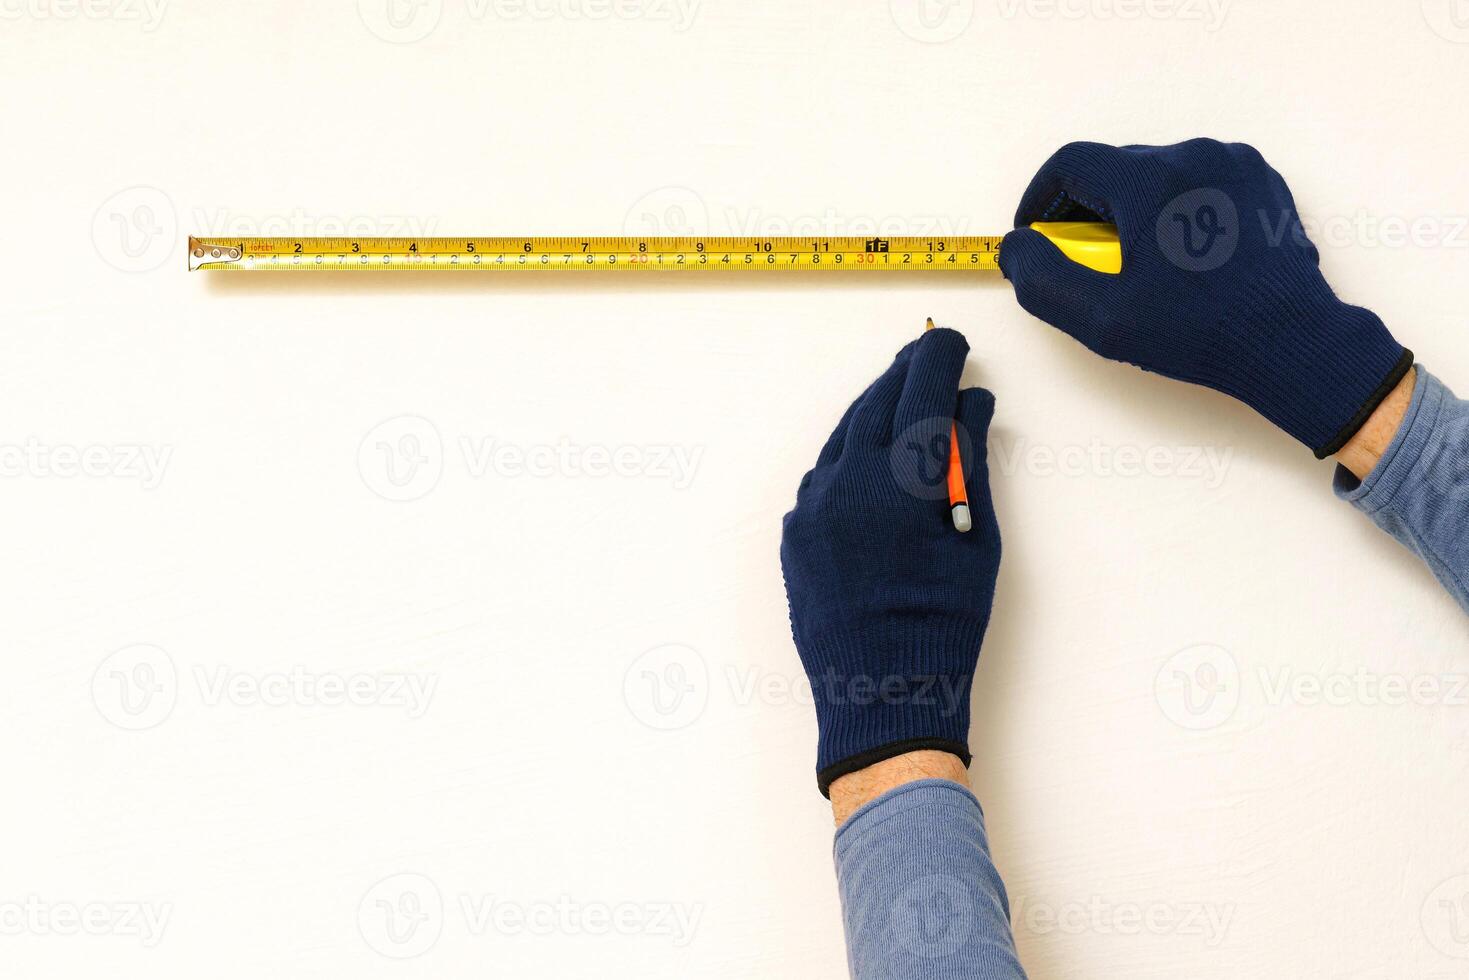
834, 779, 1025, 980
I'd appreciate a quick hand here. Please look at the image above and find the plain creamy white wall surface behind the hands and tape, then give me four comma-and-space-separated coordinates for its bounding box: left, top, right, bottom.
0, 0, 1469, 980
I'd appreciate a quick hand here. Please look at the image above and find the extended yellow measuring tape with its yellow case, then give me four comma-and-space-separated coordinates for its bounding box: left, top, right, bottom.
188, 222, 1122, 272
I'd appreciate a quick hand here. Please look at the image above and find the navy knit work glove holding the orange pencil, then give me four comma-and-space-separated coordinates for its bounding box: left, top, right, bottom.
780, 329, 1000, 795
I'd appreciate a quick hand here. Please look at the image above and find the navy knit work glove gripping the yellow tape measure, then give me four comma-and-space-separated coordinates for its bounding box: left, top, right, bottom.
999, 140, 1413, 458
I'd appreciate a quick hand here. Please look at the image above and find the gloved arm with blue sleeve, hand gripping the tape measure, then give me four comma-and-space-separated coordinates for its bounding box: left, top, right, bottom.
1000, 140, 1469, 610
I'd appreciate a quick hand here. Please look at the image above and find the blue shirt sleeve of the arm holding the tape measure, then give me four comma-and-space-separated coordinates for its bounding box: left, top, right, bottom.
1334, 364, 1469, 611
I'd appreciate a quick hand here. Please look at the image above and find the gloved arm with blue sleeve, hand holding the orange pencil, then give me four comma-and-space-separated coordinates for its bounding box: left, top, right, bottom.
780, 331, 1024, 980
